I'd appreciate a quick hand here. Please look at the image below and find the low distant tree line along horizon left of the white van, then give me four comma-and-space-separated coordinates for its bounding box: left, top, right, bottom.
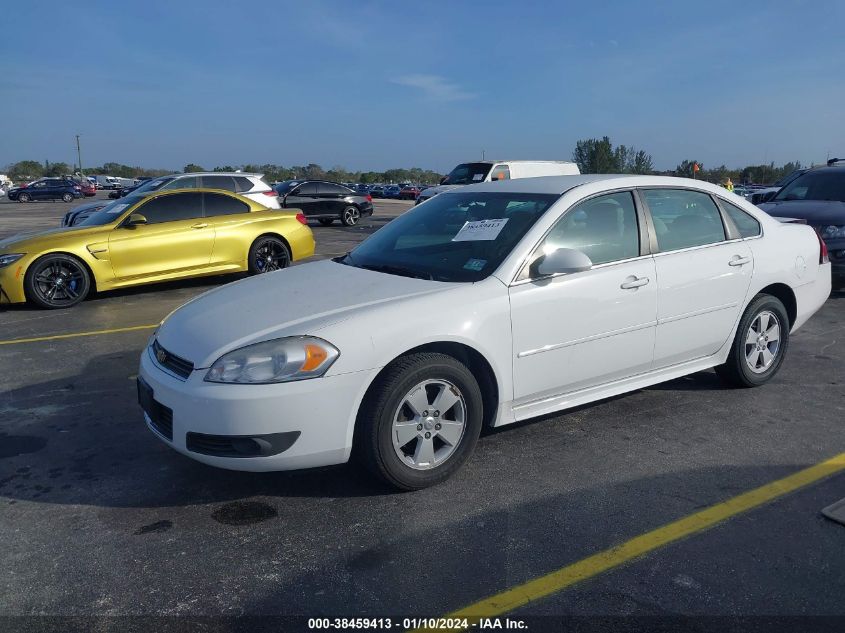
1, 160, 441, 184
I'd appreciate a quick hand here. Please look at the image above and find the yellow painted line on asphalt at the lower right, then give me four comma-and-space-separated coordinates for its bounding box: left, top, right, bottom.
426, 453, 845, 624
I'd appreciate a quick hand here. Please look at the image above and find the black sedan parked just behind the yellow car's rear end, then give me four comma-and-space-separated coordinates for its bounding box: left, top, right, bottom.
273, 180, 373, 226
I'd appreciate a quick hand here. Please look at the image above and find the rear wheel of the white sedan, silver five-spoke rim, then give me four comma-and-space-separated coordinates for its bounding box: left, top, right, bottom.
716, 295, 790, 387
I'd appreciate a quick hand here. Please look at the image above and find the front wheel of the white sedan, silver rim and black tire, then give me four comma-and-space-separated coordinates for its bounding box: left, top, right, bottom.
355, 353, 483, 490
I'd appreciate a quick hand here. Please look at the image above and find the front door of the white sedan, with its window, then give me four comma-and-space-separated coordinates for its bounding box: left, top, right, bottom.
510, 191, 657, 410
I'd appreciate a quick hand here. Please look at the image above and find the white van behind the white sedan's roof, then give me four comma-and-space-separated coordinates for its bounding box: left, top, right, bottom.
417, 160, 581, 204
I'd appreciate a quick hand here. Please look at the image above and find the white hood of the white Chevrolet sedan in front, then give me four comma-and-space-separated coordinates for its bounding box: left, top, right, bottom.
156, 260, 453, 369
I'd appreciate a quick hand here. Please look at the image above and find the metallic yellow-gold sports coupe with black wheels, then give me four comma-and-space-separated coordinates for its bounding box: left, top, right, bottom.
0, 189, 314, 308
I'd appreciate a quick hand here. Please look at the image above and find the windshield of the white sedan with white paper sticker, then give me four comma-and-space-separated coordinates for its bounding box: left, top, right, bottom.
335, 192, 559, 282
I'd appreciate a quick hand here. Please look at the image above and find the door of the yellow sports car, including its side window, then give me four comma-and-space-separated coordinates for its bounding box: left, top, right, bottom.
109, 192, 214, 279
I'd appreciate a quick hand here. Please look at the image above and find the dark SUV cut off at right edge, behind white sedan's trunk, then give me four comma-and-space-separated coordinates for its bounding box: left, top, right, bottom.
758, 158, 845, 288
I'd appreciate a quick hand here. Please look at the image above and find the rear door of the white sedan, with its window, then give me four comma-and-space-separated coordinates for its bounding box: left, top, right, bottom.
641, 188, 754, 369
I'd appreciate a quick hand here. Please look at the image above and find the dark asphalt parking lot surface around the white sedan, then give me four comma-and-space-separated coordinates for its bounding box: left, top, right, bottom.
0, 194, 845, 628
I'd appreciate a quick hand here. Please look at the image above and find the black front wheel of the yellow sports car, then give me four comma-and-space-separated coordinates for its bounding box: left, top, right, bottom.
23, 254, 91, 310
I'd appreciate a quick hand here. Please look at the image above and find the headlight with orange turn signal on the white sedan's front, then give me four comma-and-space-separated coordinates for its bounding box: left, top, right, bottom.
205, 336, 340, 384
